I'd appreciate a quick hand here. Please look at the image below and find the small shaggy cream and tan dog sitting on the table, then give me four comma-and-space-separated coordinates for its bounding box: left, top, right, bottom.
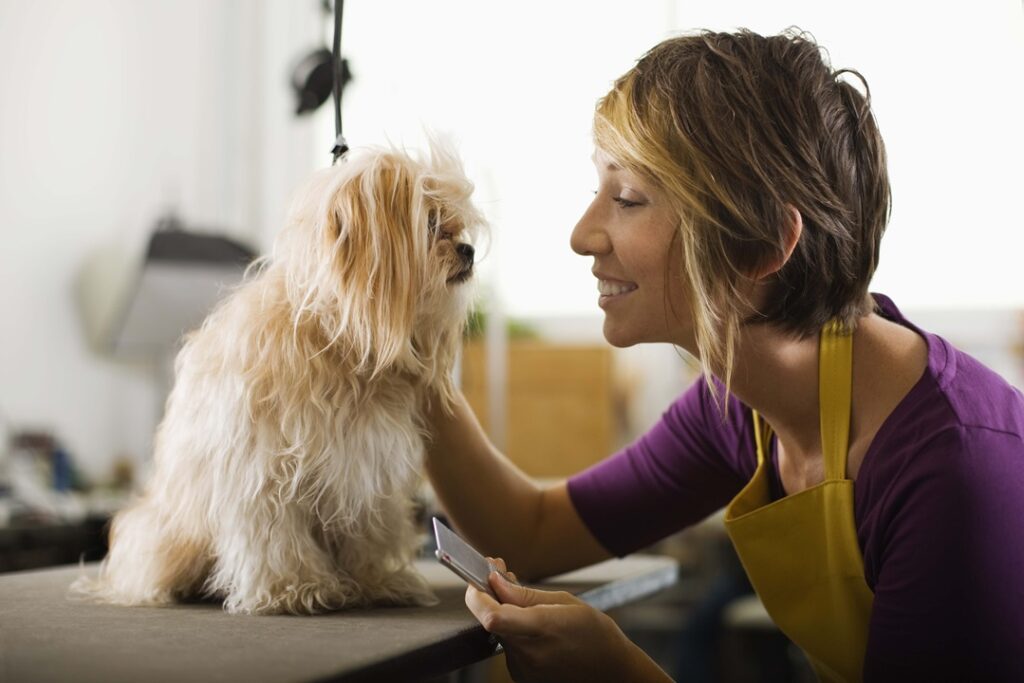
73, 142, 483, 614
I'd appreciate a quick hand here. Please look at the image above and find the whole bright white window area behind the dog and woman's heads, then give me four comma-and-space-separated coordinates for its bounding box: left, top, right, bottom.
316, 0, 1024, 316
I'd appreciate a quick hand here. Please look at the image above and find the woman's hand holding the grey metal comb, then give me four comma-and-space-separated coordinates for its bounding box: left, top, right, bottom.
466, 560, 670, 683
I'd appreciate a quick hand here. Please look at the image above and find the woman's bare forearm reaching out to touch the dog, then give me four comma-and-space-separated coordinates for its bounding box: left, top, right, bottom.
426, 393, 610, 581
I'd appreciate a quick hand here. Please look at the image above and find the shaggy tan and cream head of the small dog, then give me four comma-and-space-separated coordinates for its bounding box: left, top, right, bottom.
273, 143, 484, 393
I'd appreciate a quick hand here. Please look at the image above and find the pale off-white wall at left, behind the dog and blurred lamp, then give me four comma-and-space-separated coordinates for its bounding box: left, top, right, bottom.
0, 0, 319, 478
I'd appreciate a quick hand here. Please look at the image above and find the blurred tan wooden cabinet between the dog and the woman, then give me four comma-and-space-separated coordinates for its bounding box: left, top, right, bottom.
462, 341, 616, 478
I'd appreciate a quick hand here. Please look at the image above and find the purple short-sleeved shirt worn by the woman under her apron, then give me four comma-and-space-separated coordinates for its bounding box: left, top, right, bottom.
568, 295, 1024, 681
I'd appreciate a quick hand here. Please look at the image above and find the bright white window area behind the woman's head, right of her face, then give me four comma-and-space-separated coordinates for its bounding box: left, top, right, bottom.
677, 0, 1024, 309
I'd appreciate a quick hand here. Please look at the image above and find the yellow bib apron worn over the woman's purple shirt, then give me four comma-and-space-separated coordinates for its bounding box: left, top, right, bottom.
725, 322, 873, 681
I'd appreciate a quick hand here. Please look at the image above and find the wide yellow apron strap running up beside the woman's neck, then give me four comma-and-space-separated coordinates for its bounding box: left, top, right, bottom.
818, 321, 853, 481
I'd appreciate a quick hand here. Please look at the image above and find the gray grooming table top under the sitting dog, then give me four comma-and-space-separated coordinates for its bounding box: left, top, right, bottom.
0, 556, 677, 683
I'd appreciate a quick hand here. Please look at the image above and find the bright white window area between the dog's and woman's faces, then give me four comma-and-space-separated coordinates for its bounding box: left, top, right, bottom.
317, 0, 673, 315
